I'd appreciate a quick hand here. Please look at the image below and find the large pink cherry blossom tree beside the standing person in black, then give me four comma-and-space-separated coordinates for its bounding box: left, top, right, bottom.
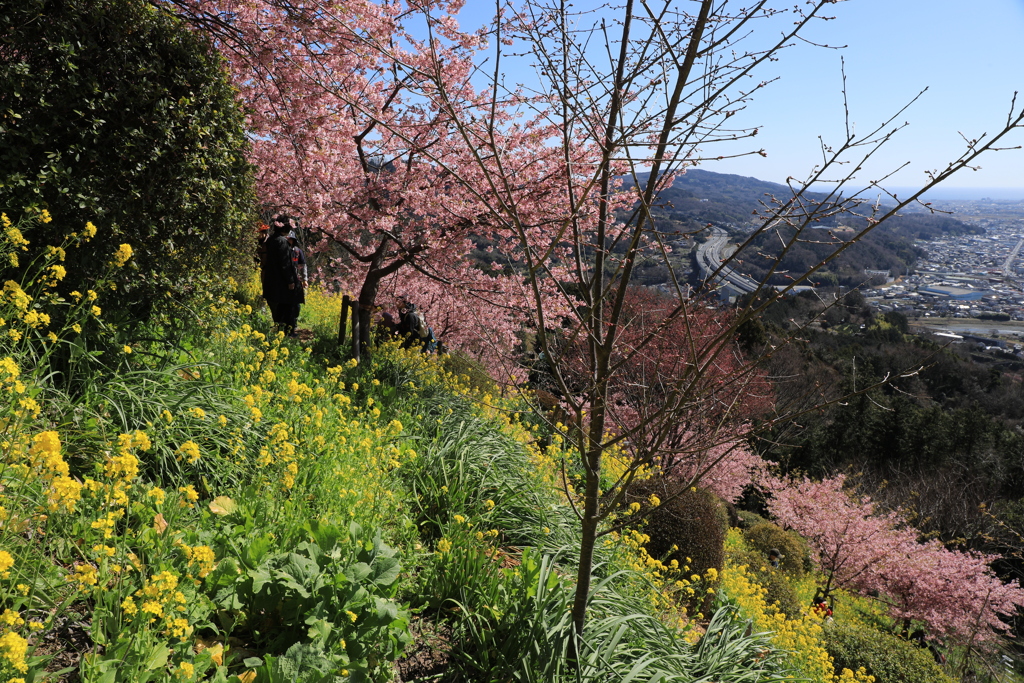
154, 0, 560, 360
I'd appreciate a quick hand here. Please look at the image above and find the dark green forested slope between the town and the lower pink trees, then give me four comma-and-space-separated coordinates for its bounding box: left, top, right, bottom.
760, 295, 1024, 598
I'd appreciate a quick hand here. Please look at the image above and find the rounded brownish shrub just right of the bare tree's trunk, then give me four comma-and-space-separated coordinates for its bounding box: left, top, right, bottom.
627, 477, 728, 574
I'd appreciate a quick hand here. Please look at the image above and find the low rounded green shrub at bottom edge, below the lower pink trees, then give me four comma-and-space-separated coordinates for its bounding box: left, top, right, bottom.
824, 624, 952, 683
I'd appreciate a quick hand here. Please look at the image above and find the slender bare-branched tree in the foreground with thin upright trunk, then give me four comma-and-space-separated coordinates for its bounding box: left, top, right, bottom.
368, 0, 1024, 647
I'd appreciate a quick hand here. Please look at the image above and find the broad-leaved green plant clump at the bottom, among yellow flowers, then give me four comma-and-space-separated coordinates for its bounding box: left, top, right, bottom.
206, 522, 409, 681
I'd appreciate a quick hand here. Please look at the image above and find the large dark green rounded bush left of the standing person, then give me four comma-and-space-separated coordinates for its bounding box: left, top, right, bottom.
0, 0, 255, 321
